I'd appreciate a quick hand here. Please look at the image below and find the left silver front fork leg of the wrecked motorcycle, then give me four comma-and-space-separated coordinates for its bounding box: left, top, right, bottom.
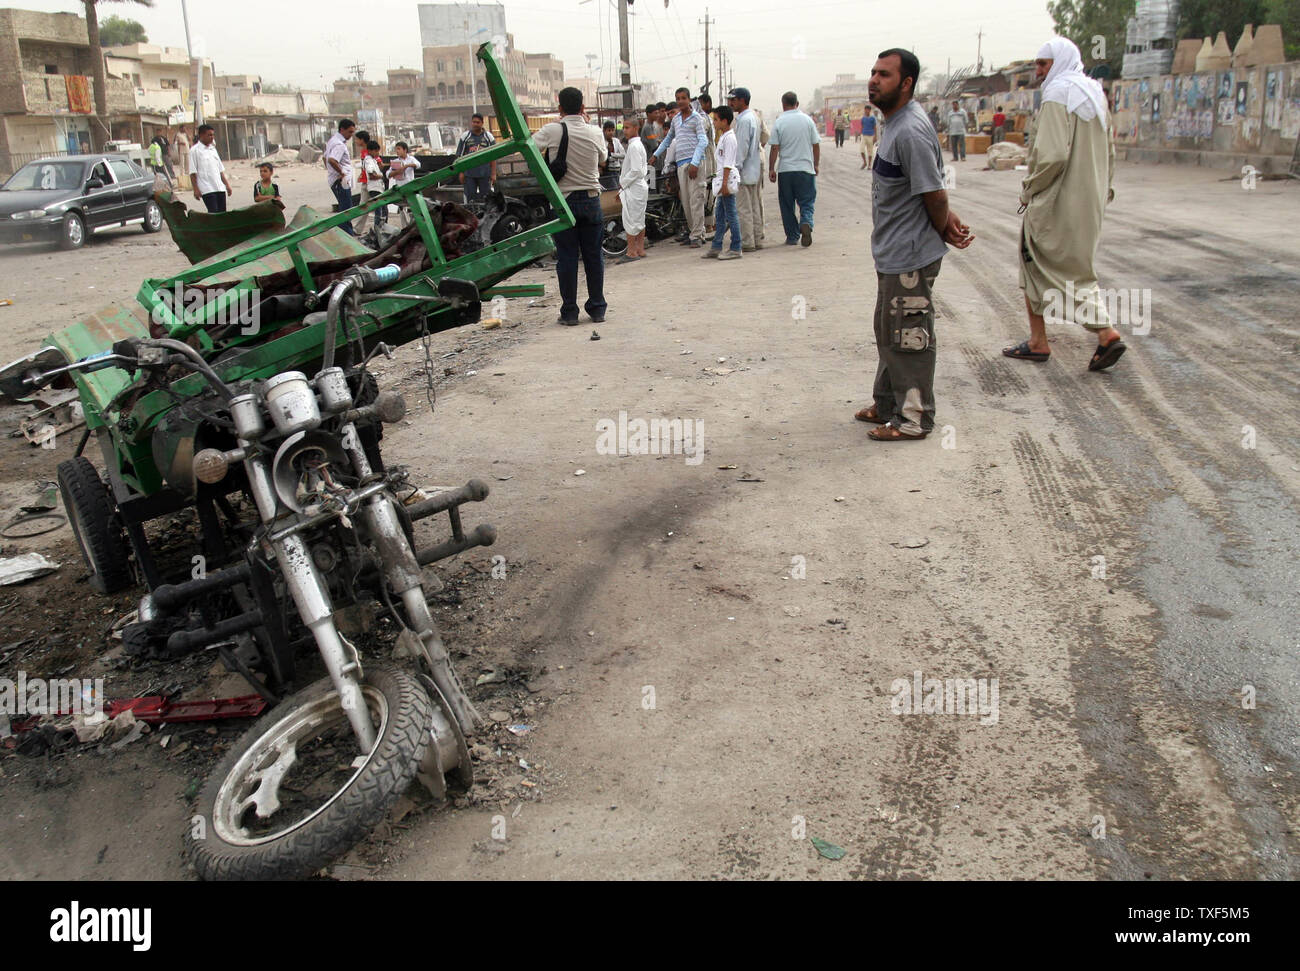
241, 442, 378, 754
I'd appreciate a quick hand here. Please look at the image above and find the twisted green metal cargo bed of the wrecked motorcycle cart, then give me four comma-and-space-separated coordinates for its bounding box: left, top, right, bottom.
47, 44, 573, 495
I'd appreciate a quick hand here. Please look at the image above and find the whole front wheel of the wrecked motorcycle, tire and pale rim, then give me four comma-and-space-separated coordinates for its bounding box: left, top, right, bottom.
186, 666, 433, 880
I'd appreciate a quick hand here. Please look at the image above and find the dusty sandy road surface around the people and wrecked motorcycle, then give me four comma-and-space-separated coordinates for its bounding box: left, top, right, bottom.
0, 143, 1300, 879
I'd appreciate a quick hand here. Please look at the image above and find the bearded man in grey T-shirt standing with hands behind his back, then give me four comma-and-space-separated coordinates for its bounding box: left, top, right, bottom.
854, 48, 974, 442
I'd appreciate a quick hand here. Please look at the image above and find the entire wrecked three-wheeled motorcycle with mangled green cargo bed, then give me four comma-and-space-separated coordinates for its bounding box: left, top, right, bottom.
0, 45, 573, 879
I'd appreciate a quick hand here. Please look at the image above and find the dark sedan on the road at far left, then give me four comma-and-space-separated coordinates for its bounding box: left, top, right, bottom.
0, 155, 163, 250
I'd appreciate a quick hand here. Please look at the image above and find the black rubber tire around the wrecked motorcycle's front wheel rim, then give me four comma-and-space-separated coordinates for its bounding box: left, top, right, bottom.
186, 664, 433, 880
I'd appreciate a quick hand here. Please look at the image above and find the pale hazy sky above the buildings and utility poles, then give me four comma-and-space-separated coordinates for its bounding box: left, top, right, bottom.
17, 0, 1053, 108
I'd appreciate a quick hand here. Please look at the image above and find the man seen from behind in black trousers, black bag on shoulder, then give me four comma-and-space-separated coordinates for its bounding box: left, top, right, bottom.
533, 87, 608, 326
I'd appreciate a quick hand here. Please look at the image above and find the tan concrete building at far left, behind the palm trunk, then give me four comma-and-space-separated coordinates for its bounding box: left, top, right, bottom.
0, 9, 135, 175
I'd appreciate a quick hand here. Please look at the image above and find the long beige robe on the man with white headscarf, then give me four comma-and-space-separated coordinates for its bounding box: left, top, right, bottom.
1021, 101, 1115, 330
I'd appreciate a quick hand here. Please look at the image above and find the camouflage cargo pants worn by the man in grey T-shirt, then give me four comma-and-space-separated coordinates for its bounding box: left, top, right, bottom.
872, 259, 943, 435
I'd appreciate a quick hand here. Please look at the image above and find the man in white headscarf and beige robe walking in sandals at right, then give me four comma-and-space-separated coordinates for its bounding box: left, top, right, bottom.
1002, 38, 1127, 370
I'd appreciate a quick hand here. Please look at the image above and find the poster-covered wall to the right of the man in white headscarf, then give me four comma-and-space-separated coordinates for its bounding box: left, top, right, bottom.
1112, 61, 1300, 159
